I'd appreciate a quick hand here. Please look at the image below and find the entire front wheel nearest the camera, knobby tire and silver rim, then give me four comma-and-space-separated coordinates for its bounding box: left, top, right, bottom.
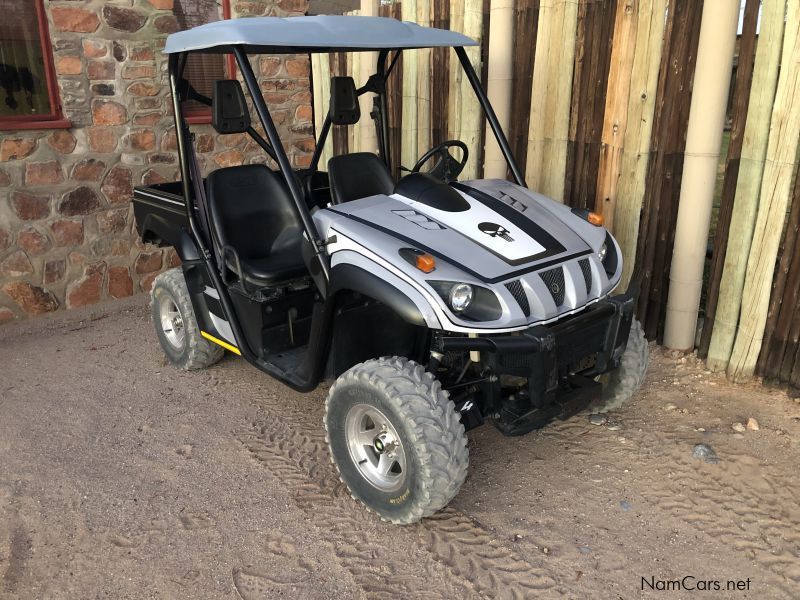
325, 357, 469, 524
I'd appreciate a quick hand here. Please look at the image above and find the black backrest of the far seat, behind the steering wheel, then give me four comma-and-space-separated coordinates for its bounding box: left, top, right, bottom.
328, 152, 394, 204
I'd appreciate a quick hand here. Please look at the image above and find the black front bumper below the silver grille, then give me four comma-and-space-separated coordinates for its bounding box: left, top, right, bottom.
434, 292, 635, 435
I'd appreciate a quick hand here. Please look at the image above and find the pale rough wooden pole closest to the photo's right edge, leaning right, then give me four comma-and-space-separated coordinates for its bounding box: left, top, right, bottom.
728, 0, 800, 381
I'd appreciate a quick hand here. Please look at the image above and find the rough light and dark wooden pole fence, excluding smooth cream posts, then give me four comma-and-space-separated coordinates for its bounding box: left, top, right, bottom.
304, 0, 800, 394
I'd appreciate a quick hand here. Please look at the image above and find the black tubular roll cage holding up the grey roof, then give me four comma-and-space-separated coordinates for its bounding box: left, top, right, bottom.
168, 46, 525, 391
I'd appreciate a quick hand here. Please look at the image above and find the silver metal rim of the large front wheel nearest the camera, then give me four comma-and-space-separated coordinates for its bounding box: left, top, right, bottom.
344, 404, 407, 492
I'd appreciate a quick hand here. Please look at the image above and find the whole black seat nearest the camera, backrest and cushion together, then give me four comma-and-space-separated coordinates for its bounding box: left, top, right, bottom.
206, 165, 306, 288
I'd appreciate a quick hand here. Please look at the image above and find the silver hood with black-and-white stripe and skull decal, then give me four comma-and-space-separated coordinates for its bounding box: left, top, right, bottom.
314, 180, 621, 331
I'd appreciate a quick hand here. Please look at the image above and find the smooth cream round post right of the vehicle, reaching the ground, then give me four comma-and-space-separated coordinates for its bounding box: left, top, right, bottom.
664, 2, 739, 350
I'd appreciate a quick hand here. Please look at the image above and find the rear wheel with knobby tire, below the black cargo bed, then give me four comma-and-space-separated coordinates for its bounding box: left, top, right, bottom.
151, 268, 225, 371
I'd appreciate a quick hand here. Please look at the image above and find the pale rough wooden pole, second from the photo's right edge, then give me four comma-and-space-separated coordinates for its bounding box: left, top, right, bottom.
707, 0, 786, 371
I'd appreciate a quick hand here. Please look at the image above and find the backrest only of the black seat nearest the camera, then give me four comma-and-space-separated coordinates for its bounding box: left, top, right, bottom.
206, 165, 302, 260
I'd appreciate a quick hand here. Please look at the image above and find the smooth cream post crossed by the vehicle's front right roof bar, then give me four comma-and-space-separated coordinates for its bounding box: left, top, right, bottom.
483, 0, 514, 179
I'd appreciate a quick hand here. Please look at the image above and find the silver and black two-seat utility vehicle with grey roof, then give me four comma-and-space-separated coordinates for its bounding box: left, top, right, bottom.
133, 16, 647, 523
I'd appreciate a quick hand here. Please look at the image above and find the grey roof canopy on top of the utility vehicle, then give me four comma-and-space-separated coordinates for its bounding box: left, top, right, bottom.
164, 15, 477, 54
